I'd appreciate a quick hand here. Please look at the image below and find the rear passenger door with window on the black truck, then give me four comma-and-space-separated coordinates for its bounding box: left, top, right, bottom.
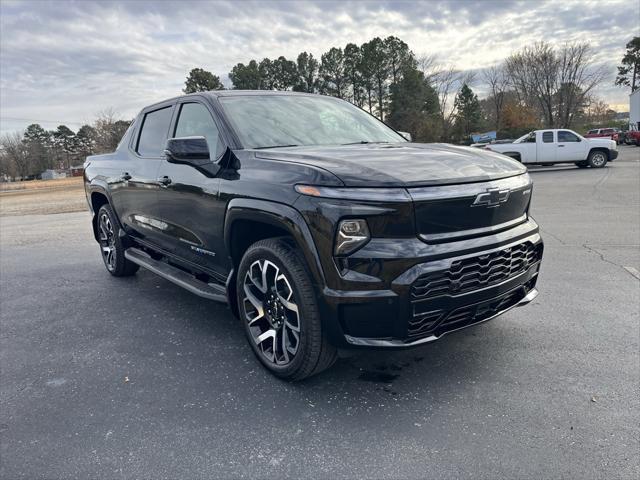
111, 103, 174, 243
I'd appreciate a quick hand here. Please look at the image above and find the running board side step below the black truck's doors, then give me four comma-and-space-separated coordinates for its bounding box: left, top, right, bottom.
124, 247, 227, 303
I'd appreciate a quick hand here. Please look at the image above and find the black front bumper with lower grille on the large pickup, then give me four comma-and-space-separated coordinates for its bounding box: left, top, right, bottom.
324, 228, 543, 348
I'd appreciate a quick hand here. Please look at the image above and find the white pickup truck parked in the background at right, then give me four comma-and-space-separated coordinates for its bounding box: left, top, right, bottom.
485, 129, 618, 168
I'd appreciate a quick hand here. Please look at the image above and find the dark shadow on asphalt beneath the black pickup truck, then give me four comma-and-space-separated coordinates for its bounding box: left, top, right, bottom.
127, 271, 509, 410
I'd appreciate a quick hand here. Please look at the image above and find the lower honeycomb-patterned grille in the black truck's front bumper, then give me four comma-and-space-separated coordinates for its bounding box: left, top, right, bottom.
411, 242, 542, 300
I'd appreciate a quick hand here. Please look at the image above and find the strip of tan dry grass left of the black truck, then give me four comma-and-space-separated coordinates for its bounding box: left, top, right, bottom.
0, 177, 88, 216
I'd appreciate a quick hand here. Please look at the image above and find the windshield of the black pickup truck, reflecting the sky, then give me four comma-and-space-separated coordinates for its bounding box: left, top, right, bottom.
220, 95, 406, 148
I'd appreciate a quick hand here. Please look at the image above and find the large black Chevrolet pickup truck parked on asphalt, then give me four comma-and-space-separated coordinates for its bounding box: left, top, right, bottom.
85, 91, 543, 380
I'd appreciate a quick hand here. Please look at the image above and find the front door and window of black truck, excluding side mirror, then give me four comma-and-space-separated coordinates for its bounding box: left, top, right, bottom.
158, 99, 227, 276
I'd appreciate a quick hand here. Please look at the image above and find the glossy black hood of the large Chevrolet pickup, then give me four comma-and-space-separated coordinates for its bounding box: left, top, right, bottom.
254, 142, 526, 187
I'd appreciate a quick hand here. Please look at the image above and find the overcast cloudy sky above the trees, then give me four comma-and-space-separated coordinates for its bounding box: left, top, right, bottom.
0, 0, 640, 131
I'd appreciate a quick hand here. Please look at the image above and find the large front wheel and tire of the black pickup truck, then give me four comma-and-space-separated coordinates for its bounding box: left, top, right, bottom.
236, 238, 337, 380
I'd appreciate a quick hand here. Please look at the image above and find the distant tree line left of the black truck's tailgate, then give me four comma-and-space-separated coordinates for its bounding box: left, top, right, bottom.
0, 110, 131, 179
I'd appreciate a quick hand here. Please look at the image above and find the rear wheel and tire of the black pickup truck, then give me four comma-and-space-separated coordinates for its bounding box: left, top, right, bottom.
96, 203, 140, 277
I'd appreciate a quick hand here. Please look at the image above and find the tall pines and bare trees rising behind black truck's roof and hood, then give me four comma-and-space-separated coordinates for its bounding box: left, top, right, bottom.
183, 36, 640, 143
